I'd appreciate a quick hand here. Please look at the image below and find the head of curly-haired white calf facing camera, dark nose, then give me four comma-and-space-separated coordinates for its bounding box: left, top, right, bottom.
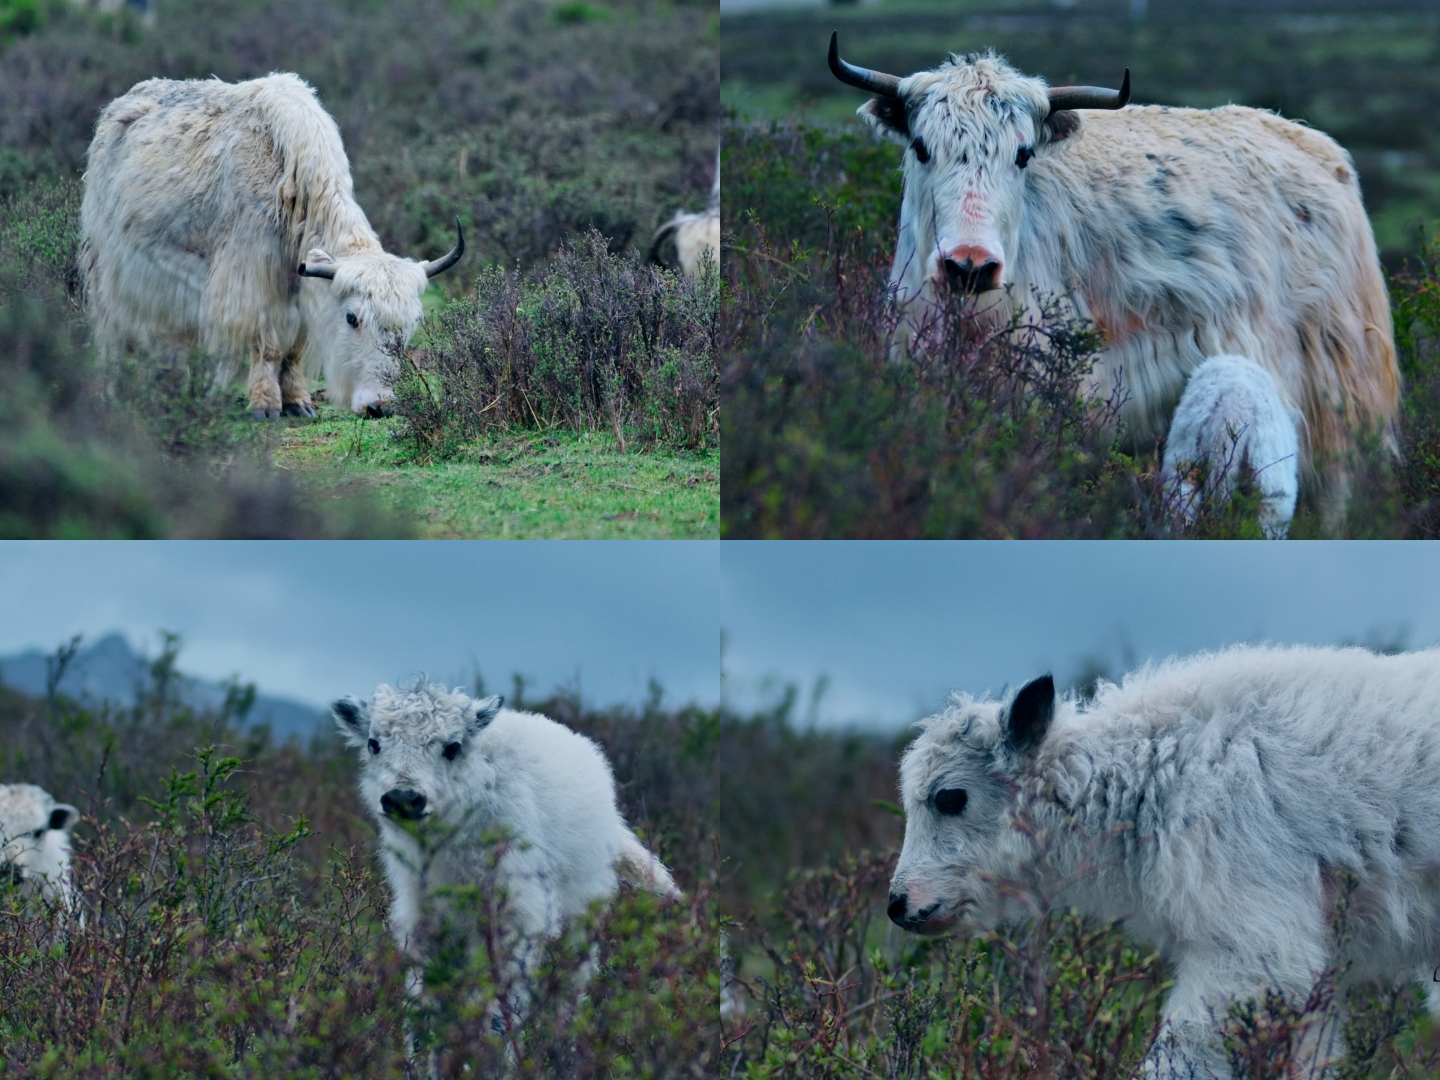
331, 681, 505, 828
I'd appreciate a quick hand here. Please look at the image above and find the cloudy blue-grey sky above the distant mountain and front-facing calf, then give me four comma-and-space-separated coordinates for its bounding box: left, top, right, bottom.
0, 540, 720, 706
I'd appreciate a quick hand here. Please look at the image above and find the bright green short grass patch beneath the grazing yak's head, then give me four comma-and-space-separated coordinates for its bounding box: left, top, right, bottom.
274, 406, 720, 540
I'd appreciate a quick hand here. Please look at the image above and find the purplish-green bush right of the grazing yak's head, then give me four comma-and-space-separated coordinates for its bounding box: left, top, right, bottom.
395, 232, 720, 459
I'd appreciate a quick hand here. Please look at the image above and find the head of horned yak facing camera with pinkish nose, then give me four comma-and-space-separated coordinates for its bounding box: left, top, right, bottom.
829, 33, 1130, 312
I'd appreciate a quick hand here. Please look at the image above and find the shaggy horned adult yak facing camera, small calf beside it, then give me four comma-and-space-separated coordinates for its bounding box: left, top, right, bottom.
829, 35, 1400, 531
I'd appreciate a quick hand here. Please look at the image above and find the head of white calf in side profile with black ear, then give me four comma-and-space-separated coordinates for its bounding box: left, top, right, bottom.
887, 675, 1056, 935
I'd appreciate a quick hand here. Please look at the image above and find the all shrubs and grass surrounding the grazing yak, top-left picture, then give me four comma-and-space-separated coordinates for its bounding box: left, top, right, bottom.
0, 0, 719, 537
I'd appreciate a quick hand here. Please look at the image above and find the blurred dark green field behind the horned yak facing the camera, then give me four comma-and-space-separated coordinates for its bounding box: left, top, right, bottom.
721, 0, 1440, 266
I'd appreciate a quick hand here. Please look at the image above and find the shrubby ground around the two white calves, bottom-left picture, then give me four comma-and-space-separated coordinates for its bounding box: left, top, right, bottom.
0, 641, 720, 1080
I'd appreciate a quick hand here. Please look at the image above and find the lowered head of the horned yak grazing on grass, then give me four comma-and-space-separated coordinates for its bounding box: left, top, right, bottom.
297, 220, 465, 416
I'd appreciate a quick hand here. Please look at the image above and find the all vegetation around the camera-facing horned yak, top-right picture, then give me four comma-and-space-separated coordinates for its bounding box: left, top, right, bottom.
721, 0, 1440, 539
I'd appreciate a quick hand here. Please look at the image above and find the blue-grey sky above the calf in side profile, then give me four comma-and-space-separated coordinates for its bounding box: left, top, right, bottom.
720, 541, 1440, 727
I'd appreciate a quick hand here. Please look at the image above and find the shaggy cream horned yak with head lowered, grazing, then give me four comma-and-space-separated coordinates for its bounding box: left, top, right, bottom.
81, 75, 465, 419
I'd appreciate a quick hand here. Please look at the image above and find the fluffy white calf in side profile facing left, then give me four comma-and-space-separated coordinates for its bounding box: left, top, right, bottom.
888, 647, 1440, 1077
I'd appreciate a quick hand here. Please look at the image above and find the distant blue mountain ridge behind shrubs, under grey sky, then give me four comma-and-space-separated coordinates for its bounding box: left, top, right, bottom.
0, 634, 325, 742
